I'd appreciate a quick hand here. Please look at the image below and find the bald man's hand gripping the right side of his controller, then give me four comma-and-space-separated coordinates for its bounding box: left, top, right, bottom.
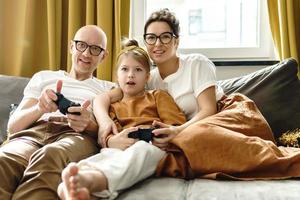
66, 100, 93, 132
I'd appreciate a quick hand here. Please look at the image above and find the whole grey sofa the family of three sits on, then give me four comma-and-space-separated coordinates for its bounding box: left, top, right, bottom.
0, 58, 300, 200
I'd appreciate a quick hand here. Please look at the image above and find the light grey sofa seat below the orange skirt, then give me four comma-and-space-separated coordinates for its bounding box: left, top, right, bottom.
117, 178, 300, 200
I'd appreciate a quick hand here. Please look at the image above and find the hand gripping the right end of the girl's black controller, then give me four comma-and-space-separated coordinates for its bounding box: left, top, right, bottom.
152, 121, 180, 150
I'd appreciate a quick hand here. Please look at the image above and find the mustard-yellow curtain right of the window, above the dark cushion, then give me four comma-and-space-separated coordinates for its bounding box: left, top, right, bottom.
267, 0, 300, 77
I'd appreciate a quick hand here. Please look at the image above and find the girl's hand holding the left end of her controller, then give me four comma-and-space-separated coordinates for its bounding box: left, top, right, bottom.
107, 127, 138, 150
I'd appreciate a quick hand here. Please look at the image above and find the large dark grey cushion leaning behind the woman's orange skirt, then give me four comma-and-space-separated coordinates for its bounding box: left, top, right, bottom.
219, 58, 300, 139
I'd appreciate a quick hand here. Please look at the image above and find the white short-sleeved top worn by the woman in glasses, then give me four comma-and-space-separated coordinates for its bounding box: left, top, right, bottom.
148, 54, 224, 119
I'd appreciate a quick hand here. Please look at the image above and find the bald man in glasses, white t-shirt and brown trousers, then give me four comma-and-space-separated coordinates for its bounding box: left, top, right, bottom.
0, 25, 114, 200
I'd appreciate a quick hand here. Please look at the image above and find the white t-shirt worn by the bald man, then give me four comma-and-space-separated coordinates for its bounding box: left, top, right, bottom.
23, 70, 115, 120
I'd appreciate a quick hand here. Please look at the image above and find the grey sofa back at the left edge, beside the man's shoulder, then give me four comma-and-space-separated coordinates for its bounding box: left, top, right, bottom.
0, 75, 29, 144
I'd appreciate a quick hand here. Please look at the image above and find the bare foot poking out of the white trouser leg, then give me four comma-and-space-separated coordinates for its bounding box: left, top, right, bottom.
57, 163, 107, 200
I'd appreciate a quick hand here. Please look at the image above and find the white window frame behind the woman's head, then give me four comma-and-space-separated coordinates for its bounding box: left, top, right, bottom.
130, 0, 276, 61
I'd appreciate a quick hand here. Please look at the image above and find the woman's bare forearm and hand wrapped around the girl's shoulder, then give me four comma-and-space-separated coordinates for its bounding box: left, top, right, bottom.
93, 88, 123, 147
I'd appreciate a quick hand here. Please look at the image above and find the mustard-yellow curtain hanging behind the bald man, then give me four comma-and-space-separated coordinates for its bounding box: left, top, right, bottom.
0, 0, 130, 80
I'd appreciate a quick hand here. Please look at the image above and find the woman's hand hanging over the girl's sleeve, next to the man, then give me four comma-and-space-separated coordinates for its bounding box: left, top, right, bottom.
98, 117, 119, 147
